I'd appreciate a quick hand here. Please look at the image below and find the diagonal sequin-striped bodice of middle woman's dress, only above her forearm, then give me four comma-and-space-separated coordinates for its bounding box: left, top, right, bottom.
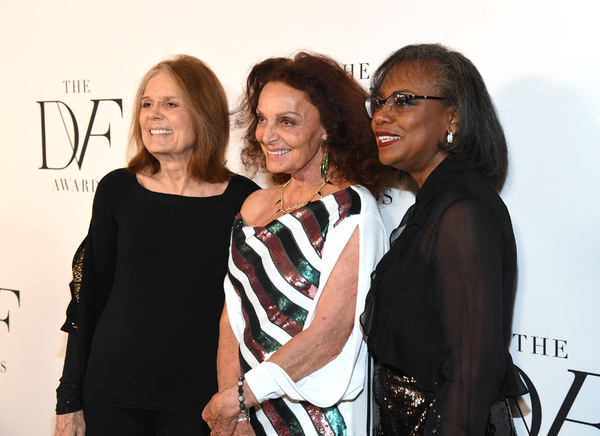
229, 190, 360, 362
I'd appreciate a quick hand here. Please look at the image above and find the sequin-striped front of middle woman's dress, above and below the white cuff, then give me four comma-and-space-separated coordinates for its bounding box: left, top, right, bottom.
229, 188, 361, 436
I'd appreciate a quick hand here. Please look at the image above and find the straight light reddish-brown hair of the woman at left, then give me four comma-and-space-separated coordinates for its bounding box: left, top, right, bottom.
128, 55, 231, 183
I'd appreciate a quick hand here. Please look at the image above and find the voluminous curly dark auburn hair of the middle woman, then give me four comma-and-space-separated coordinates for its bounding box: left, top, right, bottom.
237, 52, 382, 194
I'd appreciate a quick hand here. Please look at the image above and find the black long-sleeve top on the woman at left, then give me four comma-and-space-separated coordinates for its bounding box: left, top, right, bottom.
57, 169, 258, 413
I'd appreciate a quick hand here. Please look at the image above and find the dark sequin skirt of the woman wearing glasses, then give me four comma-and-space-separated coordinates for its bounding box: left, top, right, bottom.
373, 363, 517, 436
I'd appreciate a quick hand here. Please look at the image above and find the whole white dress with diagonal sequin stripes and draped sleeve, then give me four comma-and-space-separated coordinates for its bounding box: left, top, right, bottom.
225, 186, 386, 436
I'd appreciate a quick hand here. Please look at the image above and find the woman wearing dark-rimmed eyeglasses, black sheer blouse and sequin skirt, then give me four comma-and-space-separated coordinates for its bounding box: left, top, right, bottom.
362, 44, 525, 436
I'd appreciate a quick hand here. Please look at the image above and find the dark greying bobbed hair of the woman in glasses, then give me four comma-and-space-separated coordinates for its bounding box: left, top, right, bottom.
371, 44, 508, 190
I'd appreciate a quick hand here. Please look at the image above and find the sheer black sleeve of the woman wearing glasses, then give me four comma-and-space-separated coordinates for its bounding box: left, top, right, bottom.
425, 198, 506, 435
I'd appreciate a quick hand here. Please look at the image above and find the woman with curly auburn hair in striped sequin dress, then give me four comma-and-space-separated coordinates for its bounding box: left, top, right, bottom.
203, 53, 386, 435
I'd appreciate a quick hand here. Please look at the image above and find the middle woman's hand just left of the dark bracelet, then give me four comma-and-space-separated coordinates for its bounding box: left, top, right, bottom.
202, 387, 240, 436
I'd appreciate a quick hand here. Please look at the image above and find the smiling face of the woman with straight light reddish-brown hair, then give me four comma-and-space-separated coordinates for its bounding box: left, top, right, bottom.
139, 72, 196, 164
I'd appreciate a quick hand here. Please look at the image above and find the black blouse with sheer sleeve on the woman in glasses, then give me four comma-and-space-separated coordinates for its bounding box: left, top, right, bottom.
364, 158, 524, 435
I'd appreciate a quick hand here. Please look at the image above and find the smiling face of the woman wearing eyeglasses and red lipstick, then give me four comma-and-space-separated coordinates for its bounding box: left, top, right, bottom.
371, 64, 458, 187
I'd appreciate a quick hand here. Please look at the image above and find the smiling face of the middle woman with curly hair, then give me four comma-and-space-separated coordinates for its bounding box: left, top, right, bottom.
255, 82, 327, 179
